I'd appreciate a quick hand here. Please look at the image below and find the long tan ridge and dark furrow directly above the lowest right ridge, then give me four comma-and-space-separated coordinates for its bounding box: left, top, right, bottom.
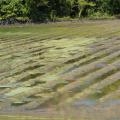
30, 62, 120, 107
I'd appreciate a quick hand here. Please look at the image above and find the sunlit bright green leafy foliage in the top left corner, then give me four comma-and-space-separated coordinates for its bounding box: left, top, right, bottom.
0, 0, 27, 18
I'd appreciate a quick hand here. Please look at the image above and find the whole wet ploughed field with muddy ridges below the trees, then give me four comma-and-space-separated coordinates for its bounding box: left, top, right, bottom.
0, 20, 120, 120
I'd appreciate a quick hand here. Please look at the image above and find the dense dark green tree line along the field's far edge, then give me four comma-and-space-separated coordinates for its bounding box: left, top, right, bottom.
0, 0, 120, 21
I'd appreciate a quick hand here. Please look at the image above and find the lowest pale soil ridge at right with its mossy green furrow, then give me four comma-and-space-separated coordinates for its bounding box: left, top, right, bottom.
64, 71, 120, 104
